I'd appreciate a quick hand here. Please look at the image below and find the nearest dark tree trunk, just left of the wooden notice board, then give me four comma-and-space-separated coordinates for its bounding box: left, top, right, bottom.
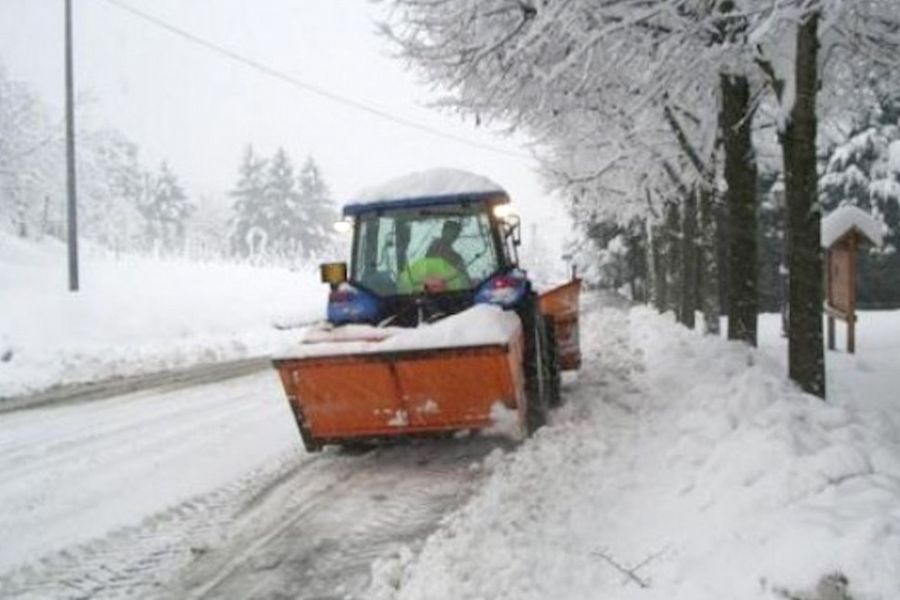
782, 12, 825, 398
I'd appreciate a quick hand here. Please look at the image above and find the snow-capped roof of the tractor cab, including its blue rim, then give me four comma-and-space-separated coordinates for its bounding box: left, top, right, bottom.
344, 169, 509, 216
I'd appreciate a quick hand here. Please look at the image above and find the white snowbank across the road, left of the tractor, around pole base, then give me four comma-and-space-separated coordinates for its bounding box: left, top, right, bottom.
0, 234, 327, 398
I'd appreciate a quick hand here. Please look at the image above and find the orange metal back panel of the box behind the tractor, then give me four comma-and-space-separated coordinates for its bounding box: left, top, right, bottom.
273, 334, 524, 450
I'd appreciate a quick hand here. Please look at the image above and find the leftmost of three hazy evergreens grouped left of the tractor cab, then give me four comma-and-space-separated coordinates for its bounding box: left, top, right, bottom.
229, 145, 268, 256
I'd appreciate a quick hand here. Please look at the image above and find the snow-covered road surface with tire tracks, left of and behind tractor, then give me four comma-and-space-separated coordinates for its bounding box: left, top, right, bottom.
0, 371, 500, 598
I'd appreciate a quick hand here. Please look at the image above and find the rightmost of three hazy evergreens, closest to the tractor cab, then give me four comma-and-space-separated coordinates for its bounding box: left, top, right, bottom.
297, 156, 338, 258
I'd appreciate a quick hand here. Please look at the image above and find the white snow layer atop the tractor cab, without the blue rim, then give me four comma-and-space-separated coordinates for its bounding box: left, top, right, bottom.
352, 169, 505, 204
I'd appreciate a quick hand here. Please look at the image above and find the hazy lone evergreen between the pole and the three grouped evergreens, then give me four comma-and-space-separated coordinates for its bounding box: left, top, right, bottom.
139, 162, 194, 253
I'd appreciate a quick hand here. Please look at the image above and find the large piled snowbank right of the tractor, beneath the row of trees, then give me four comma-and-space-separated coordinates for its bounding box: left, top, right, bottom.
370, 308, 900, 600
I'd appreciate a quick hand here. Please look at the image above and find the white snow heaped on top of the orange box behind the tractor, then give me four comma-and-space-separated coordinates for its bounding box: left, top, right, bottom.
279, 304, 522, 358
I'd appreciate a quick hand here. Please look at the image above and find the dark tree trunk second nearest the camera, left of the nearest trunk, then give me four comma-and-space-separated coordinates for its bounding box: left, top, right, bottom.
720, 74, 758, 346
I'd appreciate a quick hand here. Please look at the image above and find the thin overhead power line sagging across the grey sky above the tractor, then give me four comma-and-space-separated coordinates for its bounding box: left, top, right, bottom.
98, 0, 533, 159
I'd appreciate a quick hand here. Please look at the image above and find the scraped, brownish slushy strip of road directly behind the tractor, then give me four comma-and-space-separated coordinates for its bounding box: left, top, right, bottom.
170, 438, 506, 600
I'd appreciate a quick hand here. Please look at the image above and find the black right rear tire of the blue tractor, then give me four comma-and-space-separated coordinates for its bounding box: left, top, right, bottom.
519, 294, 549, 436
